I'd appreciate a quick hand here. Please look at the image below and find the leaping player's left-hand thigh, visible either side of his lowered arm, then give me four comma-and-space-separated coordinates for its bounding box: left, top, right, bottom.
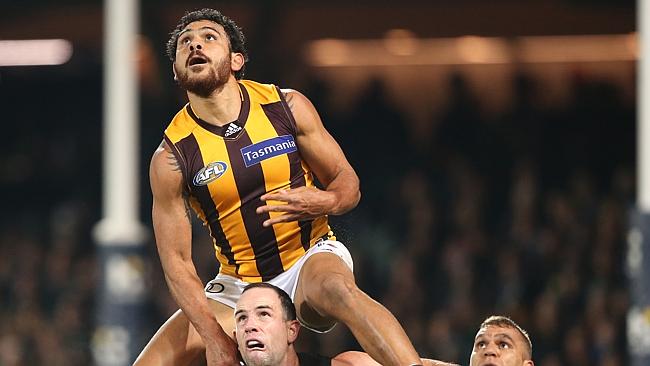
134, 300, 234, 366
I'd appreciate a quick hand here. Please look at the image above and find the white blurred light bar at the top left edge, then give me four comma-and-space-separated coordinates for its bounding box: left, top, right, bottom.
0, 39, 72, 66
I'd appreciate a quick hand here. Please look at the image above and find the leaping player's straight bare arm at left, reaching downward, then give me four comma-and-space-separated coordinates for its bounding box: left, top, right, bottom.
149, 142, 237, 365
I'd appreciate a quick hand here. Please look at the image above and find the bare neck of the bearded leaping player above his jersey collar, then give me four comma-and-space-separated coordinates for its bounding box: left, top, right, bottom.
187, 78, 242, 126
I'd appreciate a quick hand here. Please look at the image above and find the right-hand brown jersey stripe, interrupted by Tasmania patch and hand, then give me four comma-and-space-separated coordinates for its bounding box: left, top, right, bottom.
262, 102, 314, 250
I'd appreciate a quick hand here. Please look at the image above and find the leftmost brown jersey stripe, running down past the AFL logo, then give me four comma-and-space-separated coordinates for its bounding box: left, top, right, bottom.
176, 134, 235, 265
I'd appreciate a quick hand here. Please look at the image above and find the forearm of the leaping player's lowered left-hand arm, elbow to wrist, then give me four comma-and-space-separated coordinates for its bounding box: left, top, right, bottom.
163, 260, 228, 344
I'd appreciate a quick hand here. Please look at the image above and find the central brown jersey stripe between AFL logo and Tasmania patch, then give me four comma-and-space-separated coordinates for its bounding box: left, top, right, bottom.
226, 131, 284, 281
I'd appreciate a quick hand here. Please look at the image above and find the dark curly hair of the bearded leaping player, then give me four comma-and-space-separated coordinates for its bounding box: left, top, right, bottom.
167, 8, 248, 80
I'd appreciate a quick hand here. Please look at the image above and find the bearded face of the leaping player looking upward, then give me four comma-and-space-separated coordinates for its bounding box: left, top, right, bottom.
174, 20, 233, 97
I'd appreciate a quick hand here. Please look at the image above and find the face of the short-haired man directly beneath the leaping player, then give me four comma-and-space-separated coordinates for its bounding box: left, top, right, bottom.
235, 288, 298, 366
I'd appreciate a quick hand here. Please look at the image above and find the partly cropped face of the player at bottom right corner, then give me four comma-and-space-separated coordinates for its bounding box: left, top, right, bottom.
469, 325, 533, 366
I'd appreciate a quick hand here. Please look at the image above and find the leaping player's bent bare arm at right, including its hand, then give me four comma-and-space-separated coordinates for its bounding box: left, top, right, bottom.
257, 90, 361, 226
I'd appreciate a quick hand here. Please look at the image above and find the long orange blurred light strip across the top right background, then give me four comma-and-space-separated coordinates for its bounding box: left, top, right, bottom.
305, 33, 639, 67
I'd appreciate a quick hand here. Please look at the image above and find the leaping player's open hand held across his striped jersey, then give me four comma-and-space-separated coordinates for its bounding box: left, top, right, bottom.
257, 187, 336, 226
